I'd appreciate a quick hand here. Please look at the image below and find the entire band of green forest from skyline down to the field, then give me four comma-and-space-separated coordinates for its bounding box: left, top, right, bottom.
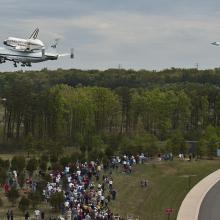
0, 69, 220, 157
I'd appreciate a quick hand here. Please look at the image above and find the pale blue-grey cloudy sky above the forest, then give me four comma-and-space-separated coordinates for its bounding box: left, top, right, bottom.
0, 0, 220, 71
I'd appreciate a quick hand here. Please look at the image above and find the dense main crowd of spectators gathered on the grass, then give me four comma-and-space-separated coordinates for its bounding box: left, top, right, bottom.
43, 154, 145, 220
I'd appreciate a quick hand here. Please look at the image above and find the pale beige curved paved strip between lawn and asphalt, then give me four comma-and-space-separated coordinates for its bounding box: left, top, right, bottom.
177, 170, 220, 220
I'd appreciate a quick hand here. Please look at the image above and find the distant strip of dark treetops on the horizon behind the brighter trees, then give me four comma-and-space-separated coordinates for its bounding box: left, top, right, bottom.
0, 68, 220, 89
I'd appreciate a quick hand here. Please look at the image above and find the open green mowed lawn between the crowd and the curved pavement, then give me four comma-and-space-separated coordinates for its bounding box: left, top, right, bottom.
111, 159, 220, 220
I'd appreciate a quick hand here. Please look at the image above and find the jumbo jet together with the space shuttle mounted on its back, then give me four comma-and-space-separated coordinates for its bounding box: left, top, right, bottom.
0, 28, 74, 67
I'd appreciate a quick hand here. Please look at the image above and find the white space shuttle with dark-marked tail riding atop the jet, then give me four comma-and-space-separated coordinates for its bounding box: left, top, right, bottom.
3, 28, 45, 52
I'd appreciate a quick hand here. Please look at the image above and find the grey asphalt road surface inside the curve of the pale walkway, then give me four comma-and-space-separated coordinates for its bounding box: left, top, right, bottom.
198, 181, 220, 220
